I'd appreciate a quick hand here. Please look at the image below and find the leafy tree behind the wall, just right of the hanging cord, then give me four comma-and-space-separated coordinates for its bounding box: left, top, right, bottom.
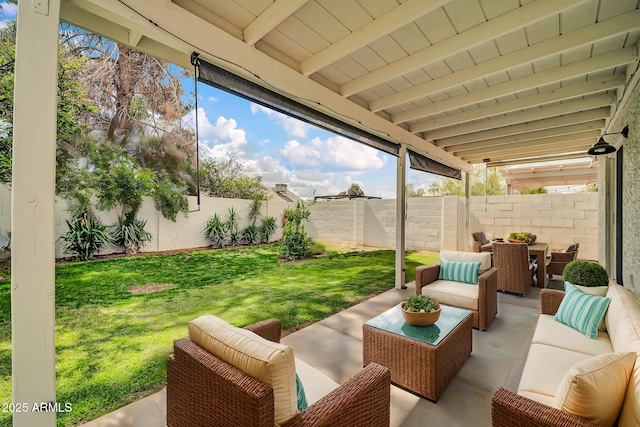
200, 153, 267, 200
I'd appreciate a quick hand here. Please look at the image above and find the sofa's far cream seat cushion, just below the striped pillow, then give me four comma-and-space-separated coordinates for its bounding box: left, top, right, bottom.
531, 314, 613, 356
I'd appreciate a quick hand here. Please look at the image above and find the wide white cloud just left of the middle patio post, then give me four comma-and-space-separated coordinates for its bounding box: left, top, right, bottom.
280, 136, 386, 173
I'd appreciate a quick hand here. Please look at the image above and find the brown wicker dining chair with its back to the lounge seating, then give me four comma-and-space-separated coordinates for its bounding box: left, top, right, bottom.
493, 243, 534, 295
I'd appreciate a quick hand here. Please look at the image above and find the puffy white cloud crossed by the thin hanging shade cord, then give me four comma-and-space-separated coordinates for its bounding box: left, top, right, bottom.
185, 108, 247, 158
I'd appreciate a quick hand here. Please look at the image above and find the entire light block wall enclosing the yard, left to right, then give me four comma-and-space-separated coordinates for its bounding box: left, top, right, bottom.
0, 187, 598, 260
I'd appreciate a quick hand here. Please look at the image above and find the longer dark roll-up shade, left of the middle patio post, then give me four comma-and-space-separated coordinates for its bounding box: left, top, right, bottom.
198, 55, 400, 156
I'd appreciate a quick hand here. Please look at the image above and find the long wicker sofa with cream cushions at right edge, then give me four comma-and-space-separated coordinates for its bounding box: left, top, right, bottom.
491, 284, 640, 427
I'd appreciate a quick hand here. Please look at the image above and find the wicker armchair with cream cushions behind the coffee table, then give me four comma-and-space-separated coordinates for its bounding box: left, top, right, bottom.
415, 251, 498, 331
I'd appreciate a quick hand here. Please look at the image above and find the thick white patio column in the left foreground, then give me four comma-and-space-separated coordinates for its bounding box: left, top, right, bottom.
11, 0, 60, 427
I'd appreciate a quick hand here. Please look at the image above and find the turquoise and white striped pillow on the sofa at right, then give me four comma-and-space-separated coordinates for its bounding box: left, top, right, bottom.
554, 282, 611, 340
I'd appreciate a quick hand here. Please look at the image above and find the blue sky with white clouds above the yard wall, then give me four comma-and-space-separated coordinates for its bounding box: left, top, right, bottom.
0, 1, 437, 198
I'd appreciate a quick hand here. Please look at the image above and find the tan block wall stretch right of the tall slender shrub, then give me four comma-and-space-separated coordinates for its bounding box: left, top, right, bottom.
306, 193, 598, 260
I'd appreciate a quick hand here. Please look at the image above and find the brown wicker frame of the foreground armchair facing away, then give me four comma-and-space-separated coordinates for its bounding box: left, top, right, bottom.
167, 319, 391, 427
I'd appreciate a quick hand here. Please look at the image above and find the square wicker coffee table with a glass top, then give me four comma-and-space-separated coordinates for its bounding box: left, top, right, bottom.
362, 305, 472, 402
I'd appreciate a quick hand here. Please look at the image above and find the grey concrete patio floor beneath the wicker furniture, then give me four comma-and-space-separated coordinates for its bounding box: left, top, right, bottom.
81, 276, 562, 427
